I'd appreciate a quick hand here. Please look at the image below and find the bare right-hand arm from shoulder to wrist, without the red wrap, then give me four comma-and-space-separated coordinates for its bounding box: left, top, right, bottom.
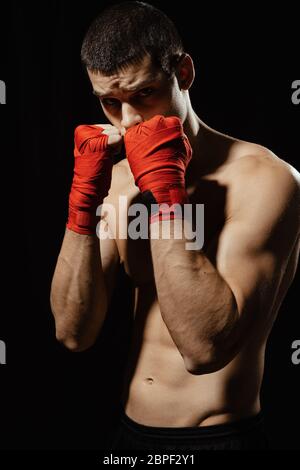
150, 162, 299, 374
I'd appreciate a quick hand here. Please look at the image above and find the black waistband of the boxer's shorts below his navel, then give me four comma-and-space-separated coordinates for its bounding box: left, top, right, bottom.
121, 410, 264, 439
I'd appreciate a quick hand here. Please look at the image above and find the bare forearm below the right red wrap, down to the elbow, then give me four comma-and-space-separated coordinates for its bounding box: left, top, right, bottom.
150, 219, 238, 370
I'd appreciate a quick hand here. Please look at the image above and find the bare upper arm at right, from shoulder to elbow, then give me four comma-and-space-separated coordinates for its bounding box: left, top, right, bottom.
217, 167, 300, 320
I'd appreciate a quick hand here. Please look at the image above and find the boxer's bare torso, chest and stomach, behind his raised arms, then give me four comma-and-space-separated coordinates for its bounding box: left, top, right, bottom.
102, 130, 296, 427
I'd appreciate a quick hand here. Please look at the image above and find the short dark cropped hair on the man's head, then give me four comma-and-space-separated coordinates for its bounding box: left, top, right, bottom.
81, 1, 184, 77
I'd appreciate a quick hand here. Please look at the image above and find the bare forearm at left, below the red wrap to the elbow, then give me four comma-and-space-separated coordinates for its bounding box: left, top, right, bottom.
50, 229, 108, 350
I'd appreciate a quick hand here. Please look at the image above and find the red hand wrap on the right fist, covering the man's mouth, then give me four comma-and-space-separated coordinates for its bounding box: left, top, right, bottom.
124, 116, 192, 222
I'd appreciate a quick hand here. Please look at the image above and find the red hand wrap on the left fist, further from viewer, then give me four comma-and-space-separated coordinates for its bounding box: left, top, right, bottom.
67, 126, 113, 235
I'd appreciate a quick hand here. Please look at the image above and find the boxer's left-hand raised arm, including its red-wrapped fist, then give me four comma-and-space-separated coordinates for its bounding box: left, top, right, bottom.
50, 125, 122, 351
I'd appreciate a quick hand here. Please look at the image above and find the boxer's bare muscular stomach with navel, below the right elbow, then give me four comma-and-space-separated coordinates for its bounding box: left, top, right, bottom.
122, 283, 264, 427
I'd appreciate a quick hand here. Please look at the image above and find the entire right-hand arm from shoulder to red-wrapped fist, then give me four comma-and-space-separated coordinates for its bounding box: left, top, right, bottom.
124, 115, 300, 374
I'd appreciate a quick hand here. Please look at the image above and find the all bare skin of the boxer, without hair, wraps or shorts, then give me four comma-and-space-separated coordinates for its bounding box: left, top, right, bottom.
52, 55, 300, 427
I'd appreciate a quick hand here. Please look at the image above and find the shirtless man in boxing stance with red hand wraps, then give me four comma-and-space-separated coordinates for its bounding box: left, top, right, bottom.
51, 2, 300, 451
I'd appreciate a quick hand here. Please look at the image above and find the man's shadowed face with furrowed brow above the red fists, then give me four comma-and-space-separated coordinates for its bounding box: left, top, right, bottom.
88, 56, 186, 133
